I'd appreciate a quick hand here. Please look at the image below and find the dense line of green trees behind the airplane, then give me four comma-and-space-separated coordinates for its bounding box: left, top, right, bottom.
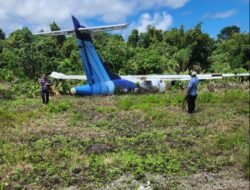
0, 22, 250, 81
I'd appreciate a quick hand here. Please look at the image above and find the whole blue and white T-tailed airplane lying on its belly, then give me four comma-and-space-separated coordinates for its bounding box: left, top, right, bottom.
34, 16, 249, 95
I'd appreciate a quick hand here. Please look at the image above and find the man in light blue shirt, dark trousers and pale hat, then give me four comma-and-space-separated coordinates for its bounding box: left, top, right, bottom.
187, 71, 199, 113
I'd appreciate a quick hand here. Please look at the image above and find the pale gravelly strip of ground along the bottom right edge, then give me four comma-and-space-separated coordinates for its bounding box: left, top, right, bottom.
100, 171, 249, 190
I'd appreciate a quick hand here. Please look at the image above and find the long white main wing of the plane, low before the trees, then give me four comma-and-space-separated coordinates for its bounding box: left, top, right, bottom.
50, 72, 250, 81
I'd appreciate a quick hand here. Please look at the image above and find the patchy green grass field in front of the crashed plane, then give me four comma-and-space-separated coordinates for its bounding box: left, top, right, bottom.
0, 84, 249, 189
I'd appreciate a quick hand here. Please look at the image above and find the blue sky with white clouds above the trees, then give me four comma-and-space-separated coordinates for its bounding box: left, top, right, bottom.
0, 0, 249, 37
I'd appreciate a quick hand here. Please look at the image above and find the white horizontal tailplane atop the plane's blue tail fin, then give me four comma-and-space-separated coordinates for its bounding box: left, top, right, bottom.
34, 23, 128, 36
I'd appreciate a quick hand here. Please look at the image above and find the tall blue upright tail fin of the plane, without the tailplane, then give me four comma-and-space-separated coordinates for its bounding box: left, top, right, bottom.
72, 16, 119, 84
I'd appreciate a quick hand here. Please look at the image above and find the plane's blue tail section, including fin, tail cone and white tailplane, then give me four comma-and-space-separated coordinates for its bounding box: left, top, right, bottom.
36, 16, 129, 95
